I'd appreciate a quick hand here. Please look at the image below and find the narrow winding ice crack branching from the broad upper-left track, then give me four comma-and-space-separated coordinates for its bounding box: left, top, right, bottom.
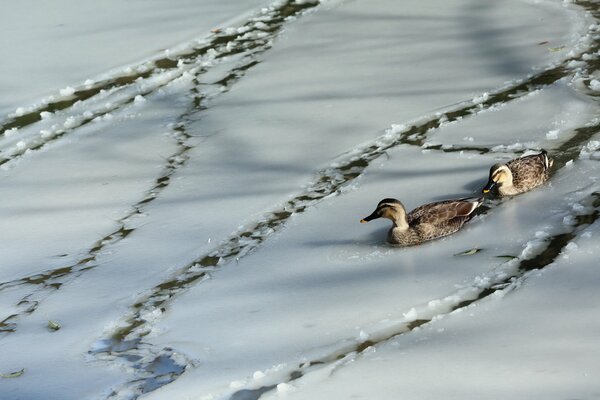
0, 1, 319, 333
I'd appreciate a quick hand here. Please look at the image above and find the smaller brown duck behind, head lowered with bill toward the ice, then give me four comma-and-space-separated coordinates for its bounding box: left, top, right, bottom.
482, 150, 554, 196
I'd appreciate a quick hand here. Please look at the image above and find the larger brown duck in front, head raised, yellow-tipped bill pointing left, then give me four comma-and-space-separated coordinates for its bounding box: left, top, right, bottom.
360, 198, 483, 246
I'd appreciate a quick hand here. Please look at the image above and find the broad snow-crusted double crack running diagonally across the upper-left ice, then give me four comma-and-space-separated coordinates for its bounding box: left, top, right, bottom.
0, 0, 320, 166
